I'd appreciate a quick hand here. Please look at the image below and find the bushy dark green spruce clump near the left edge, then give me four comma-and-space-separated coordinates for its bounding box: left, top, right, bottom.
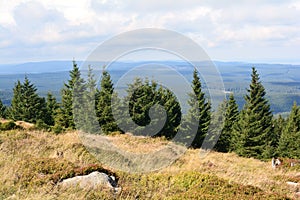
9, 77, 48, 123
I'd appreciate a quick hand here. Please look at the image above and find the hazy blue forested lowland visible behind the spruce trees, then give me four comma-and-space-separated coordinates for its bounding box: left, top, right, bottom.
0, 61, 300, 114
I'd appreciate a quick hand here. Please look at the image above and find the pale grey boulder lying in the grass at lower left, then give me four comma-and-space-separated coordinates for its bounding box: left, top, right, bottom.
59, 171, 120, 192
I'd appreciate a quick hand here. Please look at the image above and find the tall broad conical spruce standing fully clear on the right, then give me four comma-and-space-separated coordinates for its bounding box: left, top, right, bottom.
234, 68, 276, 158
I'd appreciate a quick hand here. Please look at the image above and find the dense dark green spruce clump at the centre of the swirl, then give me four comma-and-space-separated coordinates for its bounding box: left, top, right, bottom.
125, 78, 181, 139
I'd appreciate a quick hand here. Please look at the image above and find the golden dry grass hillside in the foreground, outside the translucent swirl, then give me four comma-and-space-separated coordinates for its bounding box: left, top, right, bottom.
0, 130, 300, 199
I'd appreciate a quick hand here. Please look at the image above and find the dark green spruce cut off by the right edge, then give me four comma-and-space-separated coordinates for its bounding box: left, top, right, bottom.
278, 102, 300, 159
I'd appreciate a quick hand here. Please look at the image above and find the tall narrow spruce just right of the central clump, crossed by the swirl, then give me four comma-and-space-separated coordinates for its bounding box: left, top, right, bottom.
179, 69, 211, 148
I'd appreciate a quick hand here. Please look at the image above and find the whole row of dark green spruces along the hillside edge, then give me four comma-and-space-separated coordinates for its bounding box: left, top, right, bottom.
0, 61, 300, 159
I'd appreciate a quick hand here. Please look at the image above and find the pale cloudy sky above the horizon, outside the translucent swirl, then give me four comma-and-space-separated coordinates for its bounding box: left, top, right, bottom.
0, 0, 300, 64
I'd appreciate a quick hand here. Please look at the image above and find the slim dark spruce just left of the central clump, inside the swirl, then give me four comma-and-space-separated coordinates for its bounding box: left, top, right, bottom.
96, 70, 119, 134
